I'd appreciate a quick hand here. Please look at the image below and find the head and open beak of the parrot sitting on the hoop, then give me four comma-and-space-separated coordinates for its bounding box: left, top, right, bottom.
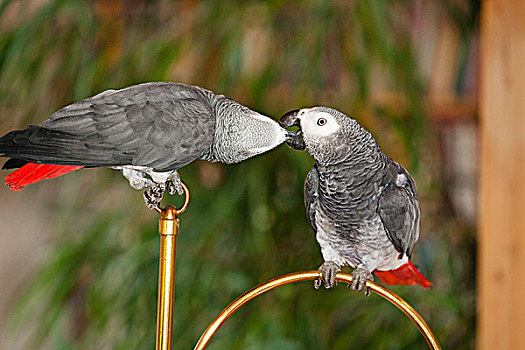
279, 107, 377, 165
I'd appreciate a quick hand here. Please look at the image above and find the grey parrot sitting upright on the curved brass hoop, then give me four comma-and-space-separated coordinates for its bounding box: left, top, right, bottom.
279, 107, 431, 294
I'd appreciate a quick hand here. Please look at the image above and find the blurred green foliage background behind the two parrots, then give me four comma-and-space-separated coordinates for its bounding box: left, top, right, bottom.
0, 0, 480, 350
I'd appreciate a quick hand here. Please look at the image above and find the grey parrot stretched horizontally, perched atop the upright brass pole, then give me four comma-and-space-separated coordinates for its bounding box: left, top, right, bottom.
0, 83, 292, 208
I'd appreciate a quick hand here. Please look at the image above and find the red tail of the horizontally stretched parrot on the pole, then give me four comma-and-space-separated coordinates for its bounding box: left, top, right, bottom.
5, 163, 83, 191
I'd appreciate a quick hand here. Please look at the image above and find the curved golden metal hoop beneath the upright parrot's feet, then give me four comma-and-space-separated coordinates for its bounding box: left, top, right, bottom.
194, 271, 441, 350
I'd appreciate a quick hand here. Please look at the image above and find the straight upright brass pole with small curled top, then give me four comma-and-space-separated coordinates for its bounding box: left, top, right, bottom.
156, 184, 190, 350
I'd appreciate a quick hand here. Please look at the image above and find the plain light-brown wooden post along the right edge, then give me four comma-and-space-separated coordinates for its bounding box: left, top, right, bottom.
477, 0, 525, 350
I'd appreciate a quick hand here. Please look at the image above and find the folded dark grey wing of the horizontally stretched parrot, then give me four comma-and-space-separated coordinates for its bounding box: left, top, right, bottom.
8, 83, 215, 171
